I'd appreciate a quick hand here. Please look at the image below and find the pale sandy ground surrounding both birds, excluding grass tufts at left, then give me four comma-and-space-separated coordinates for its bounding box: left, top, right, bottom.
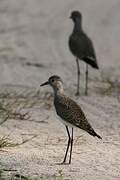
0, 0, 120, 180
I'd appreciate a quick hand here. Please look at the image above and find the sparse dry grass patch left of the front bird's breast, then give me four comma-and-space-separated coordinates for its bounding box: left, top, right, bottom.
0, 91, 52, 125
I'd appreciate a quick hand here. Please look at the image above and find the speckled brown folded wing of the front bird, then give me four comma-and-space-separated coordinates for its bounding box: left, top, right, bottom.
54, 96, 92, 132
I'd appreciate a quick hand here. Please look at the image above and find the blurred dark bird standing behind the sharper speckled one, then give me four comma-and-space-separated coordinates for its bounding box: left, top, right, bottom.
68, 11, 99, 96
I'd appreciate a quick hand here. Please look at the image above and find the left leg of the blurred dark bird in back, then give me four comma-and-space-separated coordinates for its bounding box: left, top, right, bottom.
75, 58, 80, 96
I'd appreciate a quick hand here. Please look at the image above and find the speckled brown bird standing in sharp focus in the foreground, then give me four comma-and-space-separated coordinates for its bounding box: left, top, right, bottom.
40, 75, 102, 164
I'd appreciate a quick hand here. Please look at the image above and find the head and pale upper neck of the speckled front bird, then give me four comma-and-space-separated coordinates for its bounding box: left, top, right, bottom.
40, 75, 63, 93
